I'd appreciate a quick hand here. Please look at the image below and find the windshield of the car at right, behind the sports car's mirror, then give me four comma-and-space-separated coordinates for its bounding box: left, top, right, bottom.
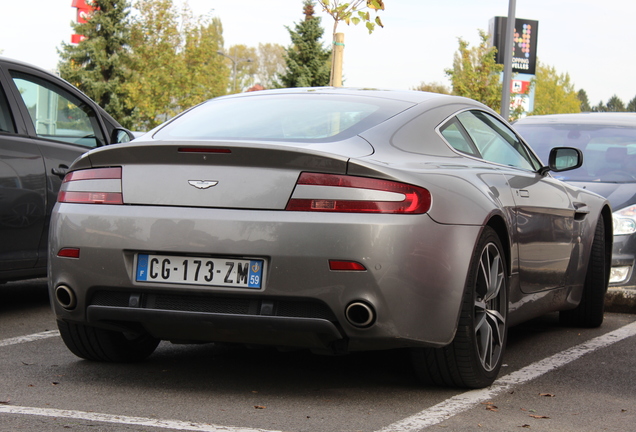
514, 124, 636, 183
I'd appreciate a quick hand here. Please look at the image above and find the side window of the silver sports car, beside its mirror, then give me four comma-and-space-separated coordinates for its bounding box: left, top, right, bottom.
457, 111, 541, 171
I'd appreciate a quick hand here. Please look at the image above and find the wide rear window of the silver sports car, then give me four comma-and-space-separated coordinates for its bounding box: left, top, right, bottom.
154, 93, 413, 142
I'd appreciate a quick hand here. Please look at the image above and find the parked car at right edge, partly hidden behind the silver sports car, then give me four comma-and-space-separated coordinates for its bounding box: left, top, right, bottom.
514, 113, 636, 287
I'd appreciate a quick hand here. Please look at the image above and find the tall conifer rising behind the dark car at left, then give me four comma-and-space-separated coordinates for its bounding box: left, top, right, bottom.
58, 0, 132, 127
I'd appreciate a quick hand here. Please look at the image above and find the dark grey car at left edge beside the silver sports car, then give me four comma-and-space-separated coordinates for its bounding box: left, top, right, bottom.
0, 57, 132, 283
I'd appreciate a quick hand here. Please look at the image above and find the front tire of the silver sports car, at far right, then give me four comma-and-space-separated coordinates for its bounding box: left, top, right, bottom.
559, 215, 609, 328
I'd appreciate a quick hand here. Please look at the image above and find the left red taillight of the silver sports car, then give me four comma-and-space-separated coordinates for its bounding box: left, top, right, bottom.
57, 167, 123, 204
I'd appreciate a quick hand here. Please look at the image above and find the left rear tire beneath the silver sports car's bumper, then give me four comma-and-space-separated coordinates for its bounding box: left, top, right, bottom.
57, 321, 159, 362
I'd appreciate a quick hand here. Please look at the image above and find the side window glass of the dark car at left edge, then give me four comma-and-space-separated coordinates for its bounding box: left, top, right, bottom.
11, 72, 105, 148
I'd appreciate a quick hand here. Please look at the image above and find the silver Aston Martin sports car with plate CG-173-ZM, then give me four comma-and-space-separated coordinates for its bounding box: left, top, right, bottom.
49, 88, 612, 388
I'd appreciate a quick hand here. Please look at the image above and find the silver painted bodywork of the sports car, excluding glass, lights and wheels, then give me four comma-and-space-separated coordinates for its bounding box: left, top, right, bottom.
49, 90, 608, 352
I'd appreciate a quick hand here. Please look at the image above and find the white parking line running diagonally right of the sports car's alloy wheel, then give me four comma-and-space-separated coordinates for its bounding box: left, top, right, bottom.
378, 322, 636, 432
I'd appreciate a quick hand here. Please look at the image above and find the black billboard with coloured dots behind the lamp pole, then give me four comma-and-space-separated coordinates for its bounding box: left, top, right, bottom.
489, 17, 539, 75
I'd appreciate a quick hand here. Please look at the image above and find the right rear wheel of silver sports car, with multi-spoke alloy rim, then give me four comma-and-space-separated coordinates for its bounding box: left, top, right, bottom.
412, 227, 508, 388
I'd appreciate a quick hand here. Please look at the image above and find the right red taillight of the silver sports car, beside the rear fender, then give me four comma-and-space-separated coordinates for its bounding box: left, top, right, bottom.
285, 173, 431, 214
